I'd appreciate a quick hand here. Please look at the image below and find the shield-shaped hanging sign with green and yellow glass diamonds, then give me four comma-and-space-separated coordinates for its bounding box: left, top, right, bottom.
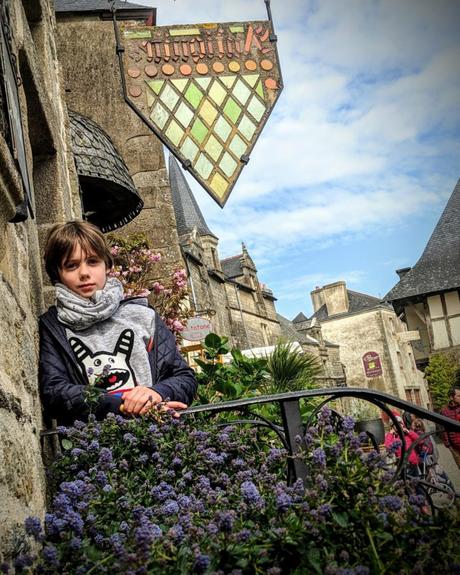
119, 21, 282, 207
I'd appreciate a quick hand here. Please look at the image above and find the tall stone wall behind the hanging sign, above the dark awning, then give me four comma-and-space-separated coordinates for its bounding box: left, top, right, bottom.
57, 15, 184, 281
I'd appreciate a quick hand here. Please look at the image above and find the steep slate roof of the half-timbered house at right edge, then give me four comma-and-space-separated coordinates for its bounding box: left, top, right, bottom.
385, 180, 460, 301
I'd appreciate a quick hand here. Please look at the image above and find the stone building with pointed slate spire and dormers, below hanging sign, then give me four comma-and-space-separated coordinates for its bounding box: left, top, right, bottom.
169, 156, 280, 349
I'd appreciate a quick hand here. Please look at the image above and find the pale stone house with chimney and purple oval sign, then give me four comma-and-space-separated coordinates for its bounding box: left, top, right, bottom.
293, 281, 429, 407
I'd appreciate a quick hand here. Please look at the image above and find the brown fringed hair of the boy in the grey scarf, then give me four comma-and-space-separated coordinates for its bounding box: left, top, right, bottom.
44, 220, 113, 285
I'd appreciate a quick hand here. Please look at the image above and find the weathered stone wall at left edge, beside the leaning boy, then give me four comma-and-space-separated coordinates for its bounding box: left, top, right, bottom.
0, 0, 81, 558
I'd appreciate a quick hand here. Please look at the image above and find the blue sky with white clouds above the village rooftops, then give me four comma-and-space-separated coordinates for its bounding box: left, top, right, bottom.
138, 0, 460, 319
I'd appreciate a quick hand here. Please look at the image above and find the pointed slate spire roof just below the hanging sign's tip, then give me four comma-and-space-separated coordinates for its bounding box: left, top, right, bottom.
169, 154, 216, 237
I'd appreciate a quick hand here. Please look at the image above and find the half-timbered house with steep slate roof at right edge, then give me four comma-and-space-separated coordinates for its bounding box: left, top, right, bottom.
385, 180, 460, 368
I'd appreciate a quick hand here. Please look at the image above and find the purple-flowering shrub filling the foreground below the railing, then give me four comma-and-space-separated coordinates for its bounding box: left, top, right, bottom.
7, 408, 460, 575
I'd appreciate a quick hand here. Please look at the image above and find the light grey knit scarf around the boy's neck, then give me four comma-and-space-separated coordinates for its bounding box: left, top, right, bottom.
56, 278, 123, 331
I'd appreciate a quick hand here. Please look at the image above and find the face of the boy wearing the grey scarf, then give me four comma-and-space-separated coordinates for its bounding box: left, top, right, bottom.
59, 244, 107, 299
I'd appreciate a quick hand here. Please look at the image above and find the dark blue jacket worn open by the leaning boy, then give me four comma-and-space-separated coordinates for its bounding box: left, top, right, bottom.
39, 299, 197, 425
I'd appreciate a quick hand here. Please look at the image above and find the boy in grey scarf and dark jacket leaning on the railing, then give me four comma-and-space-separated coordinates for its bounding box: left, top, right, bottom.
40, 221, 197, 425
